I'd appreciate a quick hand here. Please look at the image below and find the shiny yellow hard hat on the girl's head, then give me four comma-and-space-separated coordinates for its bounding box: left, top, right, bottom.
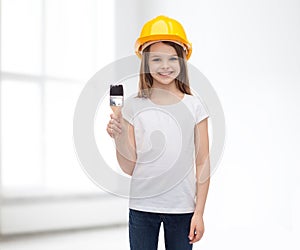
135, 16, 192, 59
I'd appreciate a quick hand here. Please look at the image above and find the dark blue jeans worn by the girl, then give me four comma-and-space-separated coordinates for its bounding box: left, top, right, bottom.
129, 209, 193, 250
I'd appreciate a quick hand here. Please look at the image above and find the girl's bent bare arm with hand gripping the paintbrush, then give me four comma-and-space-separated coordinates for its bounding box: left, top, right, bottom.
107, 114, 136, 175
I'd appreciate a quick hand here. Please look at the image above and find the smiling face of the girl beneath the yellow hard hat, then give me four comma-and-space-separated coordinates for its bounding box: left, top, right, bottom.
148, 42, 180, 85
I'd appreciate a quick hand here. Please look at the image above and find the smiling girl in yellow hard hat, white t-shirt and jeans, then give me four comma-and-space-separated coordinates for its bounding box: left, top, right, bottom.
107, 16, 210, 250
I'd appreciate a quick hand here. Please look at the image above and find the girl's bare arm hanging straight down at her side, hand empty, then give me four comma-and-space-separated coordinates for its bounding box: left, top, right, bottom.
189, 119, 210, 243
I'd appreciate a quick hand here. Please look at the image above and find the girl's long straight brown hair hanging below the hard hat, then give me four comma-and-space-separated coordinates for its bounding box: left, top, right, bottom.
138, 41, 192, 98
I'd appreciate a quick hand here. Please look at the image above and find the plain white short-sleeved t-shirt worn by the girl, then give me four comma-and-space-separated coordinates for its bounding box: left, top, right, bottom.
122, 94, 209, 213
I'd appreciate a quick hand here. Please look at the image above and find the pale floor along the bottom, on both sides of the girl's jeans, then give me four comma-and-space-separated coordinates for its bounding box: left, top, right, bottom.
0, 226, 300, 250
